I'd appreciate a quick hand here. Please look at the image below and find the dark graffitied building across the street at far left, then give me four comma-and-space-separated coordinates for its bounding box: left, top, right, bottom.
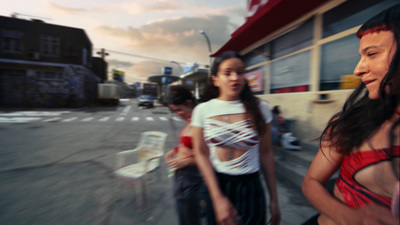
0, 16, 101, 107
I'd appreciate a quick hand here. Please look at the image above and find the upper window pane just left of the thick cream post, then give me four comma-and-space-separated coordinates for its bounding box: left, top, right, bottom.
271, 18, 314, 59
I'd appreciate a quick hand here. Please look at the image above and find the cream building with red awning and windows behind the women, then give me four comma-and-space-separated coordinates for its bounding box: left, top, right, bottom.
213, 0, 398, 143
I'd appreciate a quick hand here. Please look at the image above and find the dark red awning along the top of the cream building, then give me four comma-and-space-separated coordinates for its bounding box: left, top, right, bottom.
211, 0, 329, 57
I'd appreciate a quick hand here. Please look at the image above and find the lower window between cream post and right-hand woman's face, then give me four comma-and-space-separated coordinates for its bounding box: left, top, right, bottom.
320, 34, 360, 91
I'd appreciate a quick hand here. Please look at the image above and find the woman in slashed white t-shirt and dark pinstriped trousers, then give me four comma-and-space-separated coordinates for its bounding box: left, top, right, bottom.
191, 51, 280, 225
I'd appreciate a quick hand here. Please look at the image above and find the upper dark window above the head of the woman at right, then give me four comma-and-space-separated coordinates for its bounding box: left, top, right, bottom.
322, 0, 398, 38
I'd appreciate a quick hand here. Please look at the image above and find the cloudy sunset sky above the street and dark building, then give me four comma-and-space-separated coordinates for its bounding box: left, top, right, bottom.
0, 0, 247, 84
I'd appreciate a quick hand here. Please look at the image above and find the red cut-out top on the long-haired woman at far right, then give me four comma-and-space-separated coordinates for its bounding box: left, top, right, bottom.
336, 146, 400, 210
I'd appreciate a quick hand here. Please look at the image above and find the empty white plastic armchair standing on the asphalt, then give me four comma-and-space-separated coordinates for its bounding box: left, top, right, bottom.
114, 131, 167, 210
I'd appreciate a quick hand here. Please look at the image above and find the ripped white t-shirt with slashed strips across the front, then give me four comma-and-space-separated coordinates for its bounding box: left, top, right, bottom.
191, 99, 272, 175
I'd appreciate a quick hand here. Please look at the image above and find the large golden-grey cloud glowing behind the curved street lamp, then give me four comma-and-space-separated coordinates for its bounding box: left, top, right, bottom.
97, 15, 237, 60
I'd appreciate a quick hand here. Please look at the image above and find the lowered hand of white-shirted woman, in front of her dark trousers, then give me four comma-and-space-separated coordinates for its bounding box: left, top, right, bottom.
214, 197, 242, 225
